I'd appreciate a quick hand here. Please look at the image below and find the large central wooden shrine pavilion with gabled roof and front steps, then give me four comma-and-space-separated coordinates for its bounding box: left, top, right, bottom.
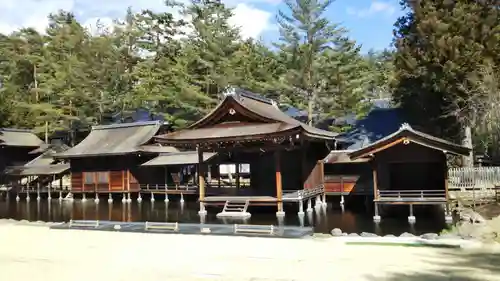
155, 89, 336, 213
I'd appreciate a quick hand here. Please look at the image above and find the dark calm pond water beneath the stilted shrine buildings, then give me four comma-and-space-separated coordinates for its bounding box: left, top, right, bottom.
0, 199, 446, 235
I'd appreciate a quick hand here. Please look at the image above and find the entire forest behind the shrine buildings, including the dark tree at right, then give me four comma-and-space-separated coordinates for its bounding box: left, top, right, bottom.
0, 0, 500, 154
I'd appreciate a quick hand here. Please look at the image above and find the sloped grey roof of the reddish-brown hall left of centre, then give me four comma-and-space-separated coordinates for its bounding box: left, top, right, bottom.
56, 121, 162, 158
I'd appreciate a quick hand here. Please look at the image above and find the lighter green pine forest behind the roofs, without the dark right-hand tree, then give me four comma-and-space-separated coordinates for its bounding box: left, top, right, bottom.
0, 0, 389, 137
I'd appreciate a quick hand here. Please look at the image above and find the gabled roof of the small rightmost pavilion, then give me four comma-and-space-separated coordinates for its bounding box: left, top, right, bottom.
349, 124, 470, 159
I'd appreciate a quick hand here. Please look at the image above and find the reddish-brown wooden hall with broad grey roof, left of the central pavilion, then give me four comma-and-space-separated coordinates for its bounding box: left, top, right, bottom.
55, 121, 177, 193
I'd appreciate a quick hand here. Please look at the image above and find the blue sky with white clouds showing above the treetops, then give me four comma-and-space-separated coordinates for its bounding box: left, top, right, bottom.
0, 0, 402, 52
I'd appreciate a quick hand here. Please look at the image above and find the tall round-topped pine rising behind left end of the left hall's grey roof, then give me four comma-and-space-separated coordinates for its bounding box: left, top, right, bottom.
40, 11, 92, 136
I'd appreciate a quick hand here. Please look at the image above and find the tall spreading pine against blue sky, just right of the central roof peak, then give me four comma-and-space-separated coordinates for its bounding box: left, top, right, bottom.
277, 0, 372, 124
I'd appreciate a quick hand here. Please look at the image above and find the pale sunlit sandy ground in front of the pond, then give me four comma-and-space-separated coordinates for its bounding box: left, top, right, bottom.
0, 223, 500, 281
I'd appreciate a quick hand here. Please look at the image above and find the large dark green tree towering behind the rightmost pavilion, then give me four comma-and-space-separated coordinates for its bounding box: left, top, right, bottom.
394, 0, 500, 141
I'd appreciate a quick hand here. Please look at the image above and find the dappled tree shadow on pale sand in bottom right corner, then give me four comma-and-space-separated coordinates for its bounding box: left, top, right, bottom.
368, 249, 500, 281
